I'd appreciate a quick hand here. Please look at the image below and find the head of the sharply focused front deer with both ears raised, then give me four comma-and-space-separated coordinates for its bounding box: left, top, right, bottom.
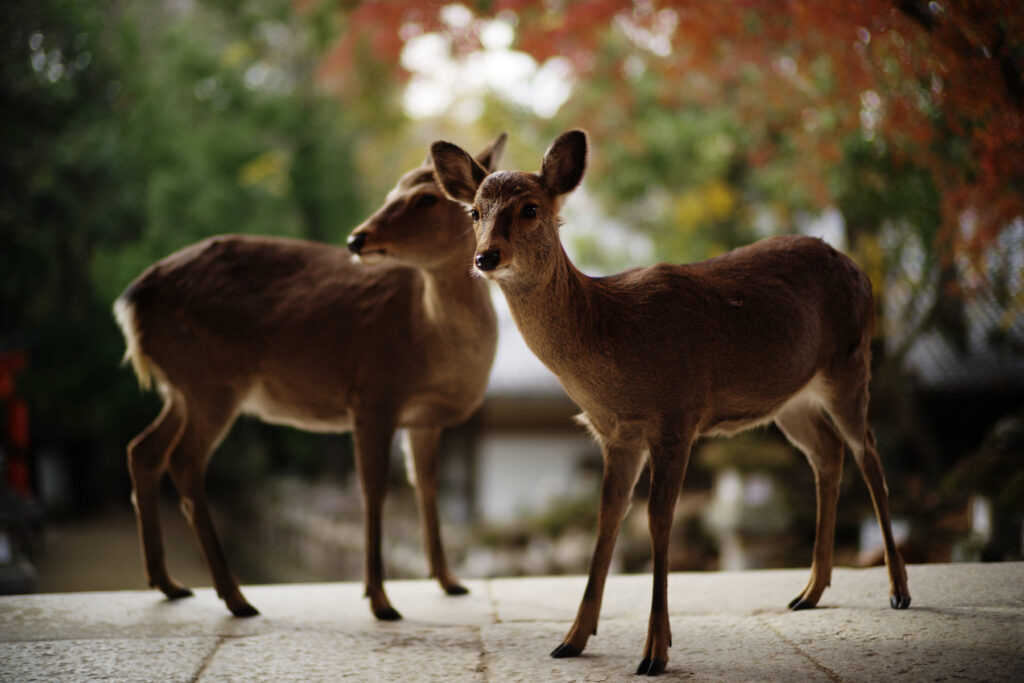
430, 130, 587, 287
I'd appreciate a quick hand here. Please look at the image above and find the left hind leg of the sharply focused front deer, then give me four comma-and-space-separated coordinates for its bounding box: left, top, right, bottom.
775, 405, 843, 609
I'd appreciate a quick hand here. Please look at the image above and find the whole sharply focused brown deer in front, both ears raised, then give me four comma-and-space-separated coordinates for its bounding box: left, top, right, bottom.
431, 130, 910, 676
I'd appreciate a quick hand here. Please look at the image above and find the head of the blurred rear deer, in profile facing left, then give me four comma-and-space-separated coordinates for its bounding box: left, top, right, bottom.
348, 133, 508, 268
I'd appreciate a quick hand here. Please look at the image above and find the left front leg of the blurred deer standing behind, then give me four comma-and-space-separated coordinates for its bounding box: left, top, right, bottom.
353, 410, 401, 622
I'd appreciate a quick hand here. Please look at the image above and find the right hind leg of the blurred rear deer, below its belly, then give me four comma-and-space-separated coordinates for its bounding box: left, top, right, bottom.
168, 389, 259, 616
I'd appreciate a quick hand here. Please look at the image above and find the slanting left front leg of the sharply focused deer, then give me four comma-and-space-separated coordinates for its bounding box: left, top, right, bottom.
551, 447, 643, 658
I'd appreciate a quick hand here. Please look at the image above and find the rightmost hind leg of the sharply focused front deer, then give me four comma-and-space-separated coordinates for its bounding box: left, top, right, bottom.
827, 370, 910, 609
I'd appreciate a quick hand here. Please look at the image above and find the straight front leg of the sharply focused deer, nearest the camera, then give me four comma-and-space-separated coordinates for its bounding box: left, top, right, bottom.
637, 439, 689, 676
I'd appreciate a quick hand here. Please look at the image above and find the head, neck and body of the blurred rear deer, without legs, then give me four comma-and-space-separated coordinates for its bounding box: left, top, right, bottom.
116, 135, 505, 430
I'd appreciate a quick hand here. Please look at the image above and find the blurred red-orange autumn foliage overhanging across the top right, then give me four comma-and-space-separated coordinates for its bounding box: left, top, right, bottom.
325, 0, 1024, 258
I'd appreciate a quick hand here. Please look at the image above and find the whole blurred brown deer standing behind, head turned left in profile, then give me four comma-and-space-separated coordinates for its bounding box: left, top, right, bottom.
115, 134, 506, 620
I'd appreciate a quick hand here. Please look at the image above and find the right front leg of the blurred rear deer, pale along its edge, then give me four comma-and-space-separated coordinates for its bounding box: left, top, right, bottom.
406, 427, 469, 595
